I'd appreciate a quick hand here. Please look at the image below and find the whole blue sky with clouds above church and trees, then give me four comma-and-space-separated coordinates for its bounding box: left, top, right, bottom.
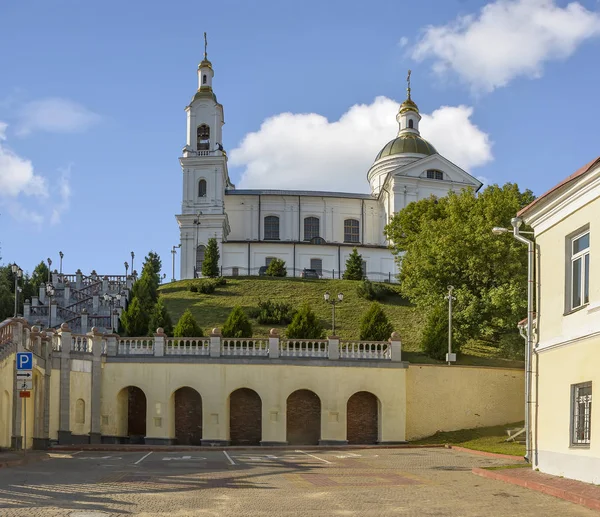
0, 0, 600, 278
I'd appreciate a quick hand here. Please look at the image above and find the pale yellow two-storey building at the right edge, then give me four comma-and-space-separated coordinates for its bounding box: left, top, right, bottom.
518, 158, 600, 484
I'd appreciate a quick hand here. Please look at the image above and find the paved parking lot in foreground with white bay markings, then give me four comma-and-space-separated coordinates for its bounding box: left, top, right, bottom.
0, 448, 599, 517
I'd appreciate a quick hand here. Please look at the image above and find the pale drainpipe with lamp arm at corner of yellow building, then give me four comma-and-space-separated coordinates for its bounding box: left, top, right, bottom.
492, 217, 535, 461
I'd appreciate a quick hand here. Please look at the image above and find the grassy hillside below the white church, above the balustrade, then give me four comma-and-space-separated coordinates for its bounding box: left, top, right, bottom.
160, 277, 523, 367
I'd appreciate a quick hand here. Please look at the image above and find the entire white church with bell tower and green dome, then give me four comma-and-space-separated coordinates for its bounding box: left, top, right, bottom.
176, 49, 482, 282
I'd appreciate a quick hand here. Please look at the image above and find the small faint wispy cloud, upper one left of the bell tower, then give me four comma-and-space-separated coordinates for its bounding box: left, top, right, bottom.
17, 98, 100, 136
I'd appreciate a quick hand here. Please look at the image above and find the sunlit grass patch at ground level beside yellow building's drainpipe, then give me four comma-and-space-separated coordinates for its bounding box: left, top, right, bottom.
411, 422, 525, 456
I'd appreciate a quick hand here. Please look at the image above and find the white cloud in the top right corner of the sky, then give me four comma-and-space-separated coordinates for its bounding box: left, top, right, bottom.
411, 0, 600, 92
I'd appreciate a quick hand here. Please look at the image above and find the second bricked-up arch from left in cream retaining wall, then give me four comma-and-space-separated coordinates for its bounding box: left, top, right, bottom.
172, 386, 202, 445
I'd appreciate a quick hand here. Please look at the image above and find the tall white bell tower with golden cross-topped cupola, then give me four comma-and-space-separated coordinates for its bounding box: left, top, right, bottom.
176, 32, 232, 279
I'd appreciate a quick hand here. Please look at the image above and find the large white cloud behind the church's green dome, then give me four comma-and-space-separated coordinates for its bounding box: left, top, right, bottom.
230, 97, 493, 192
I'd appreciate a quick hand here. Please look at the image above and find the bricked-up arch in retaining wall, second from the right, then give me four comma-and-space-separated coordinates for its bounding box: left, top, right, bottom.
286, 389, 321, 445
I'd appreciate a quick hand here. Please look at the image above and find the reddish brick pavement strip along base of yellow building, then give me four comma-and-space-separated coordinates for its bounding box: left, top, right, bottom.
473, 468, 600, 511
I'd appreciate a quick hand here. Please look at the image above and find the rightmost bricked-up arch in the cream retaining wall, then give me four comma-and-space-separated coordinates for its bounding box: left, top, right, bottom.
346, 391, 380, 444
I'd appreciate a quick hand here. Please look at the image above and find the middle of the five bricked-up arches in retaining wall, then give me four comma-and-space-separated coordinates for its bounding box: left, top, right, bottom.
229, 388, 262, 445
